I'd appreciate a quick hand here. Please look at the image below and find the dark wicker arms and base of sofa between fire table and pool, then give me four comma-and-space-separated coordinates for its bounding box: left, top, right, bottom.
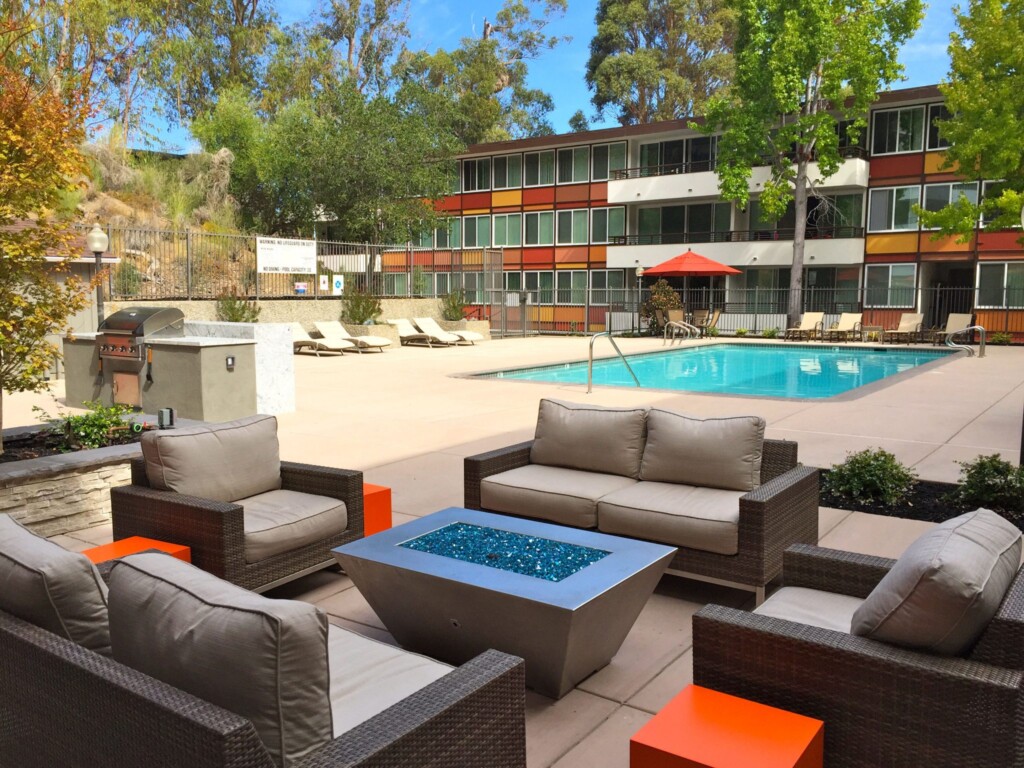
464, 439, 818, 604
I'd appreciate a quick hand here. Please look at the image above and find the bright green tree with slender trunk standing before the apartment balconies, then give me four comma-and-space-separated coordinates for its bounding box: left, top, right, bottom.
694, 0, 923, 326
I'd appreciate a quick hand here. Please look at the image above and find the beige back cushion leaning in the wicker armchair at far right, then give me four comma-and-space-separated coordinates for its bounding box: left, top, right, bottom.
853, 509, 1021, 655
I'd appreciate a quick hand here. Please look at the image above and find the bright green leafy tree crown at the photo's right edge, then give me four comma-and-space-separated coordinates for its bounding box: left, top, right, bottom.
919, 0, 1024, 242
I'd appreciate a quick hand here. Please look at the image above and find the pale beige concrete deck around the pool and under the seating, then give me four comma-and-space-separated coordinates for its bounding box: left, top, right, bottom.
4, 337, 1024, 768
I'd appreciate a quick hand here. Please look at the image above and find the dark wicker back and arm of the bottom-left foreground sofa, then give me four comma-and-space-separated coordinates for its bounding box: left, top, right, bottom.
0, 610, 526, 768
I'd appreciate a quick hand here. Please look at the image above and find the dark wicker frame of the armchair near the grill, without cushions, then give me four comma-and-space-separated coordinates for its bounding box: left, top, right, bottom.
111, 459, 364, 592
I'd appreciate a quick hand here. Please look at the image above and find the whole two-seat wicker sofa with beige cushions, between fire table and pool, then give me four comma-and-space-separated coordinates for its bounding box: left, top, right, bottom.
464, 399, 818, 604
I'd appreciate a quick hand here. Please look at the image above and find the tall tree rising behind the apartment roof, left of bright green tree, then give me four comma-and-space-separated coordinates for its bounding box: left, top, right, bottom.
587, 0, 735, 125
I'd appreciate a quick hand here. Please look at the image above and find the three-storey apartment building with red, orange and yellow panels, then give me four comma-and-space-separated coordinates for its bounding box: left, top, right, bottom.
418, 86, 1024, 334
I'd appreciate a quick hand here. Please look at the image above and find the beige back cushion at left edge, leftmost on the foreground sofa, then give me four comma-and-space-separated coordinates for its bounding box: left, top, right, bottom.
0, 514, 111, 655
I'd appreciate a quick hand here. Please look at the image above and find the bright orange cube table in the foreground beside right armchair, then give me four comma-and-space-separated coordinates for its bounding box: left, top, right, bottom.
630, 685, 824, 768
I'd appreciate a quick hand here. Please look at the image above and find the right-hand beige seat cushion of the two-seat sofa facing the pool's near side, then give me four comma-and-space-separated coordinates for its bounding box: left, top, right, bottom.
597, 481, 743, 555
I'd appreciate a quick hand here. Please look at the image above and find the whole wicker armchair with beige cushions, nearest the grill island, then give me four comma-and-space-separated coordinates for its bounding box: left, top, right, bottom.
111, 416, 364, 592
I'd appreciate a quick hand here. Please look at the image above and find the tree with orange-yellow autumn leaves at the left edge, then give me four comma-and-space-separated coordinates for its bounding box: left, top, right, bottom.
0, 60, 89, 453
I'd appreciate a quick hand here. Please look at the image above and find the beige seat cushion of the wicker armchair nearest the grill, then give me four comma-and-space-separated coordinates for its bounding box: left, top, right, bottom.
239, 490, 348, 562
